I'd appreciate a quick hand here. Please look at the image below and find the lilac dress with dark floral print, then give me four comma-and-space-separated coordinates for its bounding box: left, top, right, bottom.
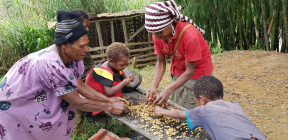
0, 49, 84, 140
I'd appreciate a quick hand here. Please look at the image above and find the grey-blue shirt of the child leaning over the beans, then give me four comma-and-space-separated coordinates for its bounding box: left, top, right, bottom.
187, 100, 266, 140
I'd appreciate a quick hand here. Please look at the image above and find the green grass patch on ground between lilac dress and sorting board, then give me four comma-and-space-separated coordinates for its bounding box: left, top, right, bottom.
70, 117, 133, 140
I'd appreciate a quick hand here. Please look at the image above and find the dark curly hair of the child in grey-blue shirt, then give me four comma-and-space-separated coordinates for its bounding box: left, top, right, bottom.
193, 76, 223, 100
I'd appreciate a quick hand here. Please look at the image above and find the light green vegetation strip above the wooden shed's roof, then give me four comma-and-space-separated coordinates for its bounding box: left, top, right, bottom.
36, 0, 160, 19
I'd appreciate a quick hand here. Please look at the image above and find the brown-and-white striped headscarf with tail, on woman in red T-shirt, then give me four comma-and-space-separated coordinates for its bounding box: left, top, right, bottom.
145, 0, 205, 34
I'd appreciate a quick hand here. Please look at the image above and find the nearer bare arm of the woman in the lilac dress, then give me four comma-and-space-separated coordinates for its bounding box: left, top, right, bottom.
60, 90, 128, 114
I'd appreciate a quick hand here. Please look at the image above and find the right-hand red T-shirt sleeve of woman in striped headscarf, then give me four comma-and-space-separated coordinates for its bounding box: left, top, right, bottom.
184, 37, 202, 61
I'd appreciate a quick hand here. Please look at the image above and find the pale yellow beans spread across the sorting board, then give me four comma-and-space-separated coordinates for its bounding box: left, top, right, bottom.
127, 101, 205, 140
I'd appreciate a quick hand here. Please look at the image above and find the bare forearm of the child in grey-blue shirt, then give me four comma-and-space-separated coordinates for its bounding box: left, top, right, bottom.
155, 106, 187, 120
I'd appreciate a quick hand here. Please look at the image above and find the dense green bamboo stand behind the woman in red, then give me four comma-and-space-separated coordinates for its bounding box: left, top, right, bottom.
175, 0, 288, 52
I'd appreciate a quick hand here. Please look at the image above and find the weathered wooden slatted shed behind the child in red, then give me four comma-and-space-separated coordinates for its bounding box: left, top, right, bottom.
88, 10, 163, 67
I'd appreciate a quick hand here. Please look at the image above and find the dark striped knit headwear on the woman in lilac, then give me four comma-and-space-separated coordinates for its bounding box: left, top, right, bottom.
54, 11, 87, 45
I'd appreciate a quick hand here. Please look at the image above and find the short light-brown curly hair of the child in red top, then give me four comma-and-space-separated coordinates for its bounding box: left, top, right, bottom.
106, 42, 130, 61
